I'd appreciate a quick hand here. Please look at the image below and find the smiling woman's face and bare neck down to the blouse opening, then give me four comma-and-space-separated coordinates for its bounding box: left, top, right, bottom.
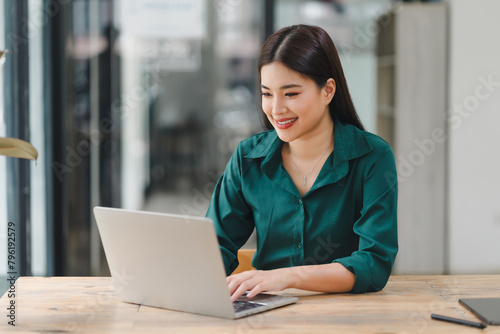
261, 62, 335, 196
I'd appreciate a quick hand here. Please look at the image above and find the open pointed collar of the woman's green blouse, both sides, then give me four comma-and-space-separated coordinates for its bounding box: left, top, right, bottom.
245, 120, 372, 190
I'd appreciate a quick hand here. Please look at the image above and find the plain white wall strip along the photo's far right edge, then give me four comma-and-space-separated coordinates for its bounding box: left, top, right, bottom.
448, 0, 500, 274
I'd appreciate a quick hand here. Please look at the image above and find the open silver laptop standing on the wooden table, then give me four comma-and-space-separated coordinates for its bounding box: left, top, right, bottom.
94, 207, 298, 319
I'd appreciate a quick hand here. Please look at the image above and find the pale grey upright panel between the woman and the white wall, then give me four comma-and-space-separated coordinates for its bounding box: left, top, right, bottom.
393, 3, 447, 274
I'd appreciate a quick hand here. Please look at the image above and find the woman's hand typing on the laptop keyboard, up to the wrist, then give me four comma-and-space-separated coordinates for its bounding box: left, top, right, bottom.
227, 268, 292, 302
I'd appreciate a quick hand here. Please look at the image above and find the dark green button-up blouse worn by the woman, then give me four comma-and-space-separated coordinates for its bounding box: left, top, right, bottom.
207, 121, 398, 293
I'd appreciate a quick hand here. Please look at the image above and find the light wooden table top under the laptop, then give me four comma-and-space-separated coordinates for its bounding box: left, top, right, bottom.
0, 275, 500, 334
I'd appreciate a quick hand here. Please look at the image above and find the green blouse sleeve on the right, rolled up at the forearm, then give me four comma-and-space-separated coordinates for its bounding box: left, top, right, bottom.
334, 144, 398, 293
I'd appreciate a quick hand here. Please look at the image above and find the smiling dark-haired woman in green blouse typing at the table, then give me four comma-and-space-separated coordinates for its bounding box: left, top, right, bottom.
207, 25, 398, 301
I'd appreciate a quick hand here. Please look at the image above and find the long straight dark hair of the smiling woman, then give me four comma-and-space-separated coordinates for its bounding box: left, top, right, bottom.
258, 24, 364, 130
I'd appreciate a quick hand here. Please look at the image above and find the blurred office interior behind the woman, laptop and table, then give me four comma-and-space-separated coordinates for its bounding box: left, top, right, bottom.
0, 0, 500, 293
